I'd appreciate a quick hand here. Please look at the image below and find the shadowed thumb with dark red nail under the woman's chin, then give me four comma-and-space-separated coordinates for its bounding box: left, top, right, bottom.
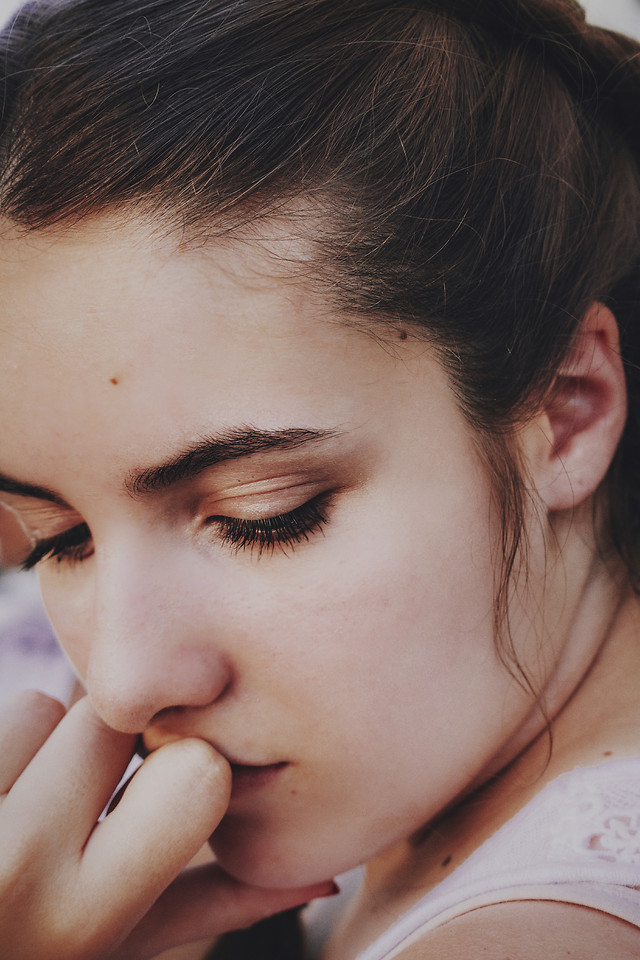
113, 864, 338, 960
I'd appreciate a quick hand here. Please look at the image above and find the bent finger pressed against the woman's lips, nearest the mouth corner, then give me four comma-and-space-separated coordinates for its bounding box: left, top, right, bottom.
81, 739, 231, 929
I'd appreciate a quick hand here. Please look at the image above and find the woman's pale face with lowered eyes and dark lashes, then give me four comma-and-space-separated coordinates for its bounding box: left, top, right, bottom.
0, 219, 552, 886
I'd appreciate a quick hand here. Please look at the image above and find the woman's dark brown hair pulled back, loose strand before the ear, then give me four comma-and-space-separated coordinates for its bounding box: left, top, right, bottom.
0, 0, 640, 662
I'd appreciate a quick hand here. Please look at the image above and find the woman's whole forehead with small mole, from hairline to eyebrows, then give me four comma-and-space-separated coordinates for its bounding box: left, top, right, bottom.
0, 218, 450, 492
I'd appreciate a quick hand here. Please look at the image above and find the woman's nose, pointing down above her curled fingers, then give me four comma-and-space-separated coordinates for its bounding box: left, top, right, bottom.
86, 537, 232, 733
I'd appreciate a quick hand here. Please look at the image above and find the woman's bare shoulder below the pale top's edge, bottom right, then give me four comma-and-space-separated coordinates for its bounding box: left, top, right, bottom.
398, 900, 640, 960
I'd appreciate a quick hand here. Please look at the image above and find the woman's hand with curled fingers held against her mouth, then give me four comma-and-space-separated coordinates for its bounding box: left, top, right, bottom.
0, 693, 332, 960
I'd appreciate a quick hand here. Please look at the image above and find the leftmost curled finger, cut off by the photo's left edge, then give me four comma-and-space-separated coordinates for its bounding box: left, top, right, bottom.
0, 690, 66, 794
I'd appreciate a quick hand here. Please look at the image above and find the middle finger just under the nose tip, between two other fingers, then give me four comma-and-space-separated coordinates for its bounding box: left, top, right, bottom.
3, 698, 135, 857
